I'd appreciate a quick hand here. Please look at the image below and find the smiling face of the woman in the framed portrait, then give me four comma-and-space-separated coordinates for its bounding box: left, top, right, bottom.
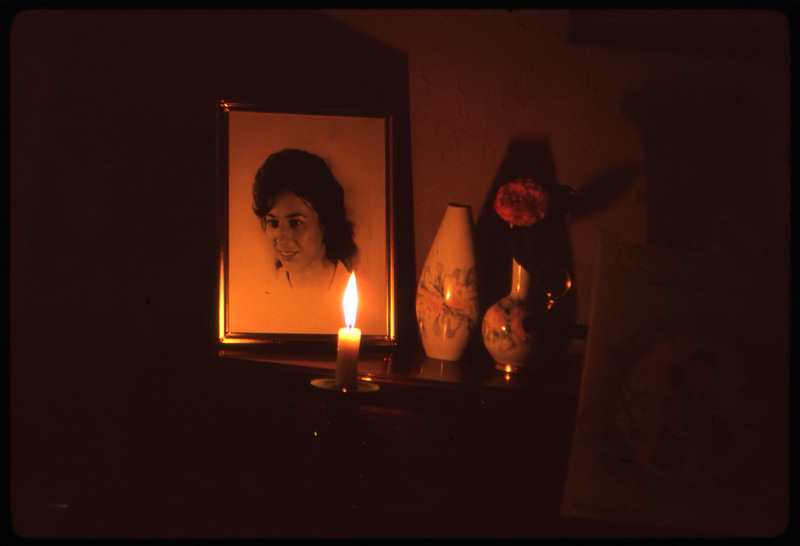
265, 192, 325, 273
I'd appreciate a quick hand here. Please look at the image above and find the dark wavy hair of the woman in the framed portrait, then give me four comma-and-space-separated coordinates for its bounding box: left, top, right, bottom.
253, 148, 358, 271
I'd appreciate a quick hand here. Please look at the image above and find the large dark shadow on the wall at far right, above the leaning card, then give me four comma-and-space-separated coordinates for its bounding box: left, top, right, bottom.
622, 78, 790, 271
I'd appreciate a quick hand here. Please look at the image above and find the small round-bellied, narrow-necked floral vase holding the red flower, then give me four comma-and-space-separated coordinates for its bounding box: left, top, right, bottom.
481, 259, 535, 371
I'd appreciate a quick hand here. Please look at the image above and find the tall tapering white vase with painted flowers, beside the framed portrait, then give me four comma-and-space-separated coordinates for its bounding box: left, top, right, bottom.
416, 203, 478, 361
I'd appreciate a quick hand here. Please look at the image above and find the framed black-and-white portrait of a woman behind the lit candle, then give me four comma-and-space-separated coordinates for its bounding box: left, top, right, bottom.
217, 101, 396, 346
